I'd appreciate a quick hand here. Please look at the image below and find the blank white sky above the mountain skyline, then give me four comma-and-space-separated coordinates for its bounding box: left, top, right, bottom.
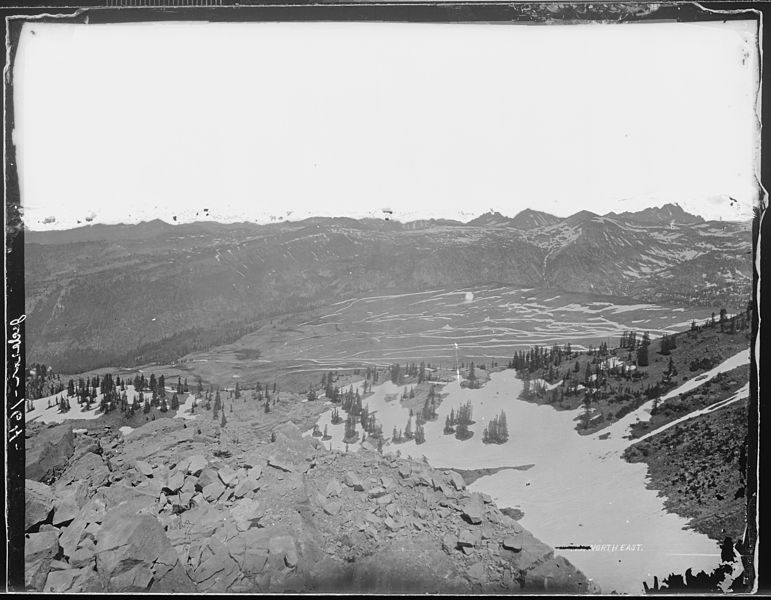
13, 21, 759, 230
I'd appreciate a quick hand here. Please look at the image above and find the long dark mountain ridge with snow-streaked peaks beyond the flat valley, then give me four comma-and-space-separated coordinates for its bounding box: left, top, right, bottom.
25, 204, 752, 372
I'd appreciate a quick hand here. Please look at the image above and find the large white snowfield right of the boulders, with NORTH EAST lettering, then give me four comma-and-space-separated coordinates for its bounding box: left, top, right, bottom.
308, 351, 748, 594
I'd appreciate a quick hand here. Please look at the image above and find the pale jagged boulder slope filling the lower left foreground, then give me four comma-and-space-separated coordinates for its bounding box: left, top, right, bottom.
25, 419, 594, 593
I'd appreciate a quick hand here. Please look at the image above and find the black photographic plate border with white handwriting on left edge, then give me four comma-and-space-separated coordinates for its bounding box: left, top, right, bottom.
0, 0, 771, 592
